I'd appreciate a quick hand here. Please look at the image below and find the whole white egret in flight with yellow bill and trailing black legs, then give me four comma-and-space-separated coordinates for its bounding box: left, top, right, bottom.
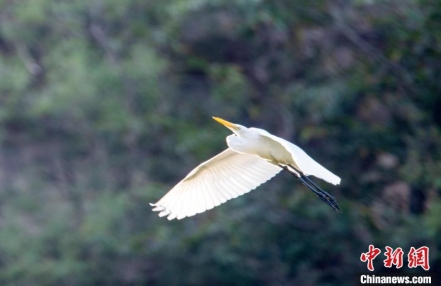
150, 117, 340, 220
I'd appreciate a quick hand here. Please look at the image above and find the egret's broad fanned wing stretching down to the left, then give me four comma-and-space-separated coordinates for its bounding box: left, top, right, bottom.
150, 148, 282, 220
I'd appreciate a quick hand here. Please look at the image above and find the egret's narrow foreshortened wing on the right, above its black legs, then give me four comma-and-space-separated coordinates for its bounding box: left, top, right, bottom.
260, 130, 341, 185
